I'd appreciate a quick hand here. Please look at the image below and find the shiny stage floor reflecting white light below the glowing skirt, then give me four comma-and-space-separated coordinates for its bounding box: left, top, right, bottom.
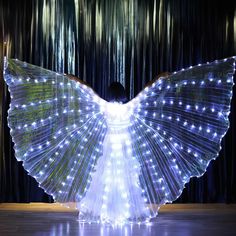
0, 203, 236, 236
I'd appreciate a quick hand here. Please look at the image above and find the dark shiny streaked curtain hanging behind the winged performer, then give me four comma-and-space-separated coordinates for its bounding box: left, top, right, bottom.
0, 0, 236, 203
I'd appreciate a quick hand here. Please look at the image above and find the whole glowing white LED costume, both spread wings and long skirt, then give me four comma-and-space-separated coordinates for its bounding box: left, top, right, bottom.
4, 57, 235, 224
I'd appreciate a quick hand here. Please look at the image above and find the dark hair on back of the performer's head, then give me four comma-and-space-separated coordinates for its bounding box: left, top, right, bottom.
106, 82, 128, 103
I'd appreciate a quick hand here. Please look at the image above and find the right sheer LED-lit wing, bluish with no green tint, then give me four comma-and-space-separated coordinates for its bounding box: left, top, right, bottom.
127, 58, 235, 209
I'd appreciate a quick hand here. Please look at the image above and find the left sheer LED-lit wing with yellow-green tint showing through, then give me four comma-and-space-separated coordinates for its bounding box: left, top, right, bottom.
4, 59, 106, 202
